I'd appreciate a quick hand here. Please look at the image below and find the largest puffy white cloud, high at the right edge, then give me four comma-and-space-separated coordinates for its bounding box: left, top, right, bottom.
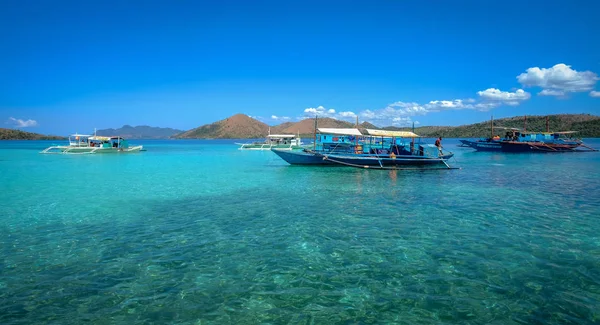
517, 63, 598, 96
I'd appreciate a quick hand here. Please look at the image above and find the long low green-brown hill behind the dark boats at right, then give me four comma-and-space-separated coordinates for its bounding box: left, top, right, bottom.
385, 114, 600, 138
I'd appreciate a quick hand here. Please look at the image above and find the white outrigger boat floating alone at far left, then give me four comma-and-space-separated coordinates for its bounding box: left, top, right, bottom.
40, 133, 143, 154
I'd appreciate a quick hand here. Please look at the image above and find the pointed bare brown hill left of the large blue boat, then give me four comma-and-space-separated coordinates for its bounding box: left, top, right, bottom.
174, 114, 269, 139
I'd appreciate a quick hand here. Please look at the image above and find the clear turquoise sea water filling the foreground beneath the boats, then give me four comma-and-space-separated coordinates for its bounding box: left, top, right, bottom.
0, 139, 600, 324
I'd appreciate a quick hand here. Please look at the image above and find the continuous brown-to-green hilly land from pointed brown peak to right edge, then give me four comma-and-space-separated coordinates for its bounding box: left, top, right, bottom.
173, 114, 600, 139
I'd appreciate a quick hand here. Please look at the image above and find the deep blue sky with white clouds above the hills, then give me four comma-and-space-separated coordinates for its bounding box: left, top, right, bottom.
0, 0, 600, 134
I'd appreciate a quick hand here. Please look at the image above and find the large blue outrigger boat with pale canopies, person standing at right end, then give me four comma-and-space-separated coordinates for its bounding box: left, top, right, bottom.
272, 128, 454, 169
